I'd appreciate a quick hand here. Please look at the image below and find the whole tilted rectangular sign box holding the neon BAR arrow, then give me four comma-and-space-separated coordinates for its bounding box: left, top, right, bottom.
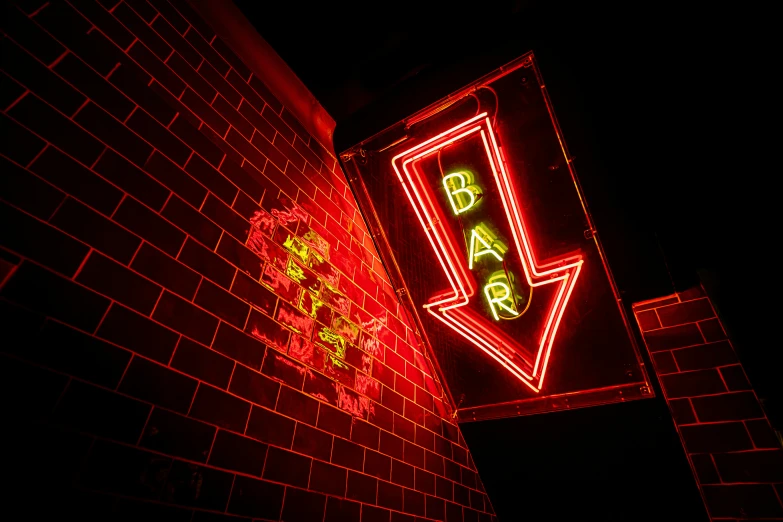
340, 53, 652, 421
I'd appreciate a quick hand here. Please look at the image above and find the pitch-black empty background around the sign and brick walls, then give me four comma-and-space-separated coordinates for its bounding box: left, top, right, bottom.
236, 0, 783, 521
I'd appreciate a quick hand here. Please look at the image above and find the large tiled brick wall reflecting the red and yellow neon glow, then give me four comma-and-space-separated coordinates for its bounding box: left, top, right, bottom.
0, 0, 495, 522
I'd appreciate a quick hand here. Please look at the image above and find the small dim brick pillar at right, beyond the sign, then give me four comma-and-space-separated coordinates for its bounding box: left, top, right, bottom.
634, 288, 783, 520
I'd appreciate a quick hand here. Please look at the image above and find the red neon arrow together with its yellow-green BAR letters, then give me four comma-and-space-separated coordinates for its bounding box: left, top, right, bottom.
392, 112, 584, 392
